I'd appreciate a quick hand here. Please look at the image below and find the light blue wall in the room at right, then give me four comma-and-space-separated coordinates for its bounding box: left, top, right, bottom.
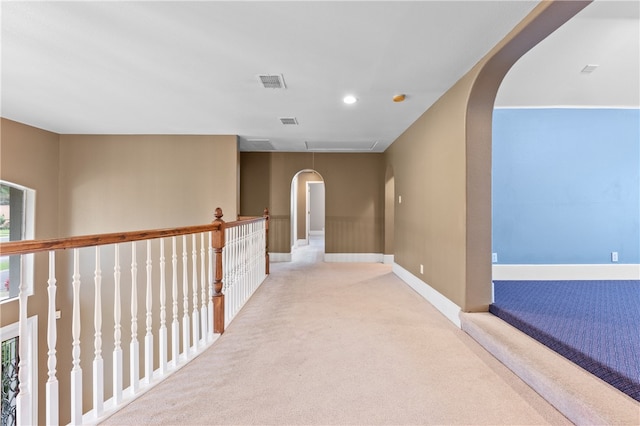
492, 108, 640, 264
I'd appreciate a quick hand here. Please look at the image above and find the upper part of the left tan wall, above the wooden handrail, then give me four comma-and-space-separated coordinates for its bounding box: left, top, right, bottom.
60, 135, 238, 235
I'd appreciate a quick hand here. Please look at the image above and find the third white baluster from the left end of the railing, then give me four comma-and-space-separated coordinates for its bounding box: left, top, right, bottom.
71, 249, 82, 425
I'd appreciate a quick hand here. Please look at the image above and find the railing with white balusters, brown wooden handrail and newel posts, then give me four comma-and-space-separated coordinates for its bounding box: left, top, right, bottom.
0, 209, 269, 425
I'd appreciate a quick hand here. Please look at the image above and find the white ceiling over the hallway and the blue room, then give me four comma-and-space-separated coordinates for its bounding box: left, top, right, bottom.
0, 0, 640, 152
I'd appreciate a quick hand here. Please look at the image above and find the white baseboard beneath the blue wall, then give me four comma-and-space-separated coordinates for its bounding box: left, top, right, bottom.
493, 264, 640, 281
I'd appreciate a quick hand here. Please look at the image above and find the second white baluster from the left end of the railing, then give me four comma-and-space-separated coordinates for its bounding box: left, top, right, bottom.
46, 251, 60, 425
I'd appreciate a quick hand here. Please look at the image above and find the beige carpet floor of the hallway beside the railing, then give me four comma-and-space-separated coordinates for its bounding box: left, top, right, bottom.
104, 240, 570, 425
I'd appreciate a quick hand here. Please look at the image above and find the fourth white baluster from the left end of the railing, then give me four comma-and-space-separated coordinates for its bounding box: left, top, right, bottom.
93, 246, 104, 417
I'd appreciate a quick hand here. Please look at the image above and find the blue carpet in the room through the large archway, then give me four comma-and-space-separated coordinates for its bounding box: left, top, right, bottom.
489, 280, 640, 401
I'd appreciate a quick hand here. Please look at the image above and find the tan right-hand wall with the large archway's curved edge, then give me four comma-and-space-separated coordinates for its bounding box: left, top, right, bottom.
386, 1, 589, 311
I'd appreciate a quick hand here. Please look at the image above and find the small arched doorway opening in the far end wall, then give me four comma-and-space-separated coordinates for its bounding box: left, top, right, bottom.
291, 169, 325, 254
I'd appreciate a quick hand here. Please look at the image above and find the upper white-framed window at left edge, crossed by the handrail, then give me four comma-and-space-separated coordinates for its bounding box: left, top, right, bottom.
0, 181, 35, 301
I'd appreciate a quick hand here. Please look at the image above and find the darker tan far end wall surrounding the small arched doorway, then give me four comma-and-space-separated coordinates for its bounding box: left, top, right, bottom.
240, 152, 385, 253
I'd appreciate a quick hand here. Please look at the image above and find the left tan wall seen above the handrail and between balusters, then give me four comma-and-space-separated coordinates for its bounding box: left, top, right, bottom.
58, 135, 238, 420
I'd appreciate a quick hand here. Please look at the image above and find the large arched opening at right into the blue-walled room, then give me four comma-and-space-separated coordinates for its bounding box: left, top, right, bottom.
489, 2, 640, 401
